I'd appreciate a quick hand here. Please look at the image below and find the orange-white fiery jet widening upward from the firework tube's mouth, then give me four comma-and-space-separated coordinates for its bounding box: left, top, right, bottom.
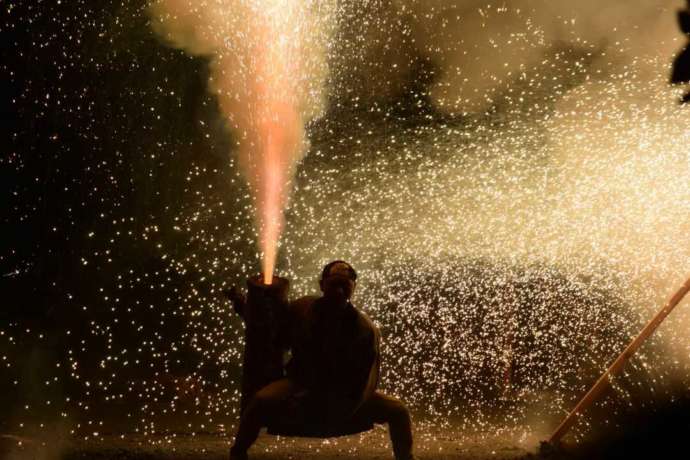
151, 0, 332, 284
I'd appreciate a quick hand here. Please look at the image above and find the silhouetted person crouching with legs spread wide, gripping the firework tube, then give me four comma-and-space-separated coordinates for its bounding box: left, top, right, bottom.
227, 260, 414, 460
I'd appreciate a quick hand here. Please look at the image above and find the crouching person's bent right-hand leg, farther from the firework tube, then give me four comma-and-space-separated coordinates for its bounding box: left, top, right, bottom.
356, 391, 414, 460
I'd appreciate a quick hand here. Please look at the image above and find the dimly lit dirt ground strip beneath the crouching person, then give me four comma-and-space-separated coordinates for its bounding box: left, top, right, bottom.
0, 427, 537, 460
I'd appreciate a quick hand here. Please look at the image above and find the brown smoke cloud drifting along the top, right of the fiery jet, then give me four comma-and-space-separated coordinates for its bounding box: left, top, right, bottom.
331, 0, 683, 113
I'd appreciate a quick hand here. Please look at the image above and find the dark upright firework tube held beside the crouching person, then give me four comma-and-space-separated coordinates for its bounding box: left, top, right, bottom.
240, 276, 290, 412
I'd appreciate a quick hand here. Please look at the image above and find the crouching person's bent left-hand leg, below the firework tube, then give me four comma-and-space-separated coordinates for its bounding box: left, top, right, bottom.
230, 379, 296, 458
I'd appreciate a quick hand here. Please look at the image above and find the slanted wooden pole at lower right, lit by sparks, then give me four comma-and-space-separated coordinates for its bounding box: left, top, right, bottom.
549, 279, 690, 445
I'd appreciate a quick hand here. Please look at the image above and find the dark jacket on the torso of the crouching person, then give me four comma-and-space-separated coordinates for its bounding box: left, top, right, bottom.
287, 297, 380, 420
